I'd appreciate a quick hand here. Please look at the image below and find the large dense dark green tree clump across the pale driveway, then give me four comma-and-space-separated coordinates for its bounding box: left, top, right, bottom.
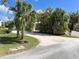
38, 8, 68, 34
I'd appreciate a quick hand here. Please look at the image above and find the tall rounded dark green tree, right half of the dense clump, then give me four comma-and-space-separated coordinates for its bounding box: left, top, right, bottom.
51, 8, 68, 34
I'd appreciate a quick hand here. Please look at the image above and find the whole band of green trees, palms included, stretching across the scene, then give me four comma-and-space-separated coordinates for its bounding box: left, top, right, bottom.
2, 0, 79, 35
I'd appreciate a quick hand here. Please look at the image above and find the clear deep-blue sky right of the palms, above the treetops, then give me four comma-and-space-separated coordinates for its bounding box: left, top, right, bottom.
27, 0, 79, 12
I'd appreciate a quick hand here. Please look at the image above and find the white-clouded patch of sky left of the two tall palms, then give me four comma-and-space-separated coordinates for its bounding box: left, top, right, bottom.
0, 5, 14, 22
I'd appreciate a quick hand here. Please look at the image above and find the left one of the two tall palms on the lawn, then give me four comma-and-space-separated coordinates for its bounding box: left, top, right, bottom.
11, 0, 21, 38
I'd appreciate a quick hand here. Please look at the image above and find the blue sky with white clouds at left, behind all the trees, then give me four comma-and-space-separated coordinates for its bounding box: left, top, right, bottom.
0, 0, 79, 19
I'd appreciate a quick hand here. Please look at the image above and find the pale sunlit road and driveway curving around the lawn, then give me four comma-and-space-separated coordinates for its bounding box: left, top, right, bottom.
0, 33, 79, 59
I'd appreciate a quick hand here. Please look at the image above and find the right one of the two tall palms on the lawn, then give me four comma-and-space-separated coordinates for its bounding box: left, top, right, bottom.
20, 2, 32, 39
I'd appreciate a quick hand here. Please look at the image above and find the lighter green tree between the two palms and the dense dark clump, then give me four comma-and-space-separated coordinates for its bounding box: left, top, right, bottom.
26, 10, 37, 31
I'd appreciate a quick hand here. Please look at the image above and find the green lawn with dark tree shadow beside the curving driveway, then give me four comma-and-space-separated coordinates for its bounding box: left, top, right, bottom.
0, 33, 39, 56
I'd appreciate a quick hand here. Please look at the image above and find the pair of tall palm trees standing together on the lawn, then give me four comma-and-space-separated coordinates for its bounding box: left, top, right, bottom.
11, 0, 32, 39
